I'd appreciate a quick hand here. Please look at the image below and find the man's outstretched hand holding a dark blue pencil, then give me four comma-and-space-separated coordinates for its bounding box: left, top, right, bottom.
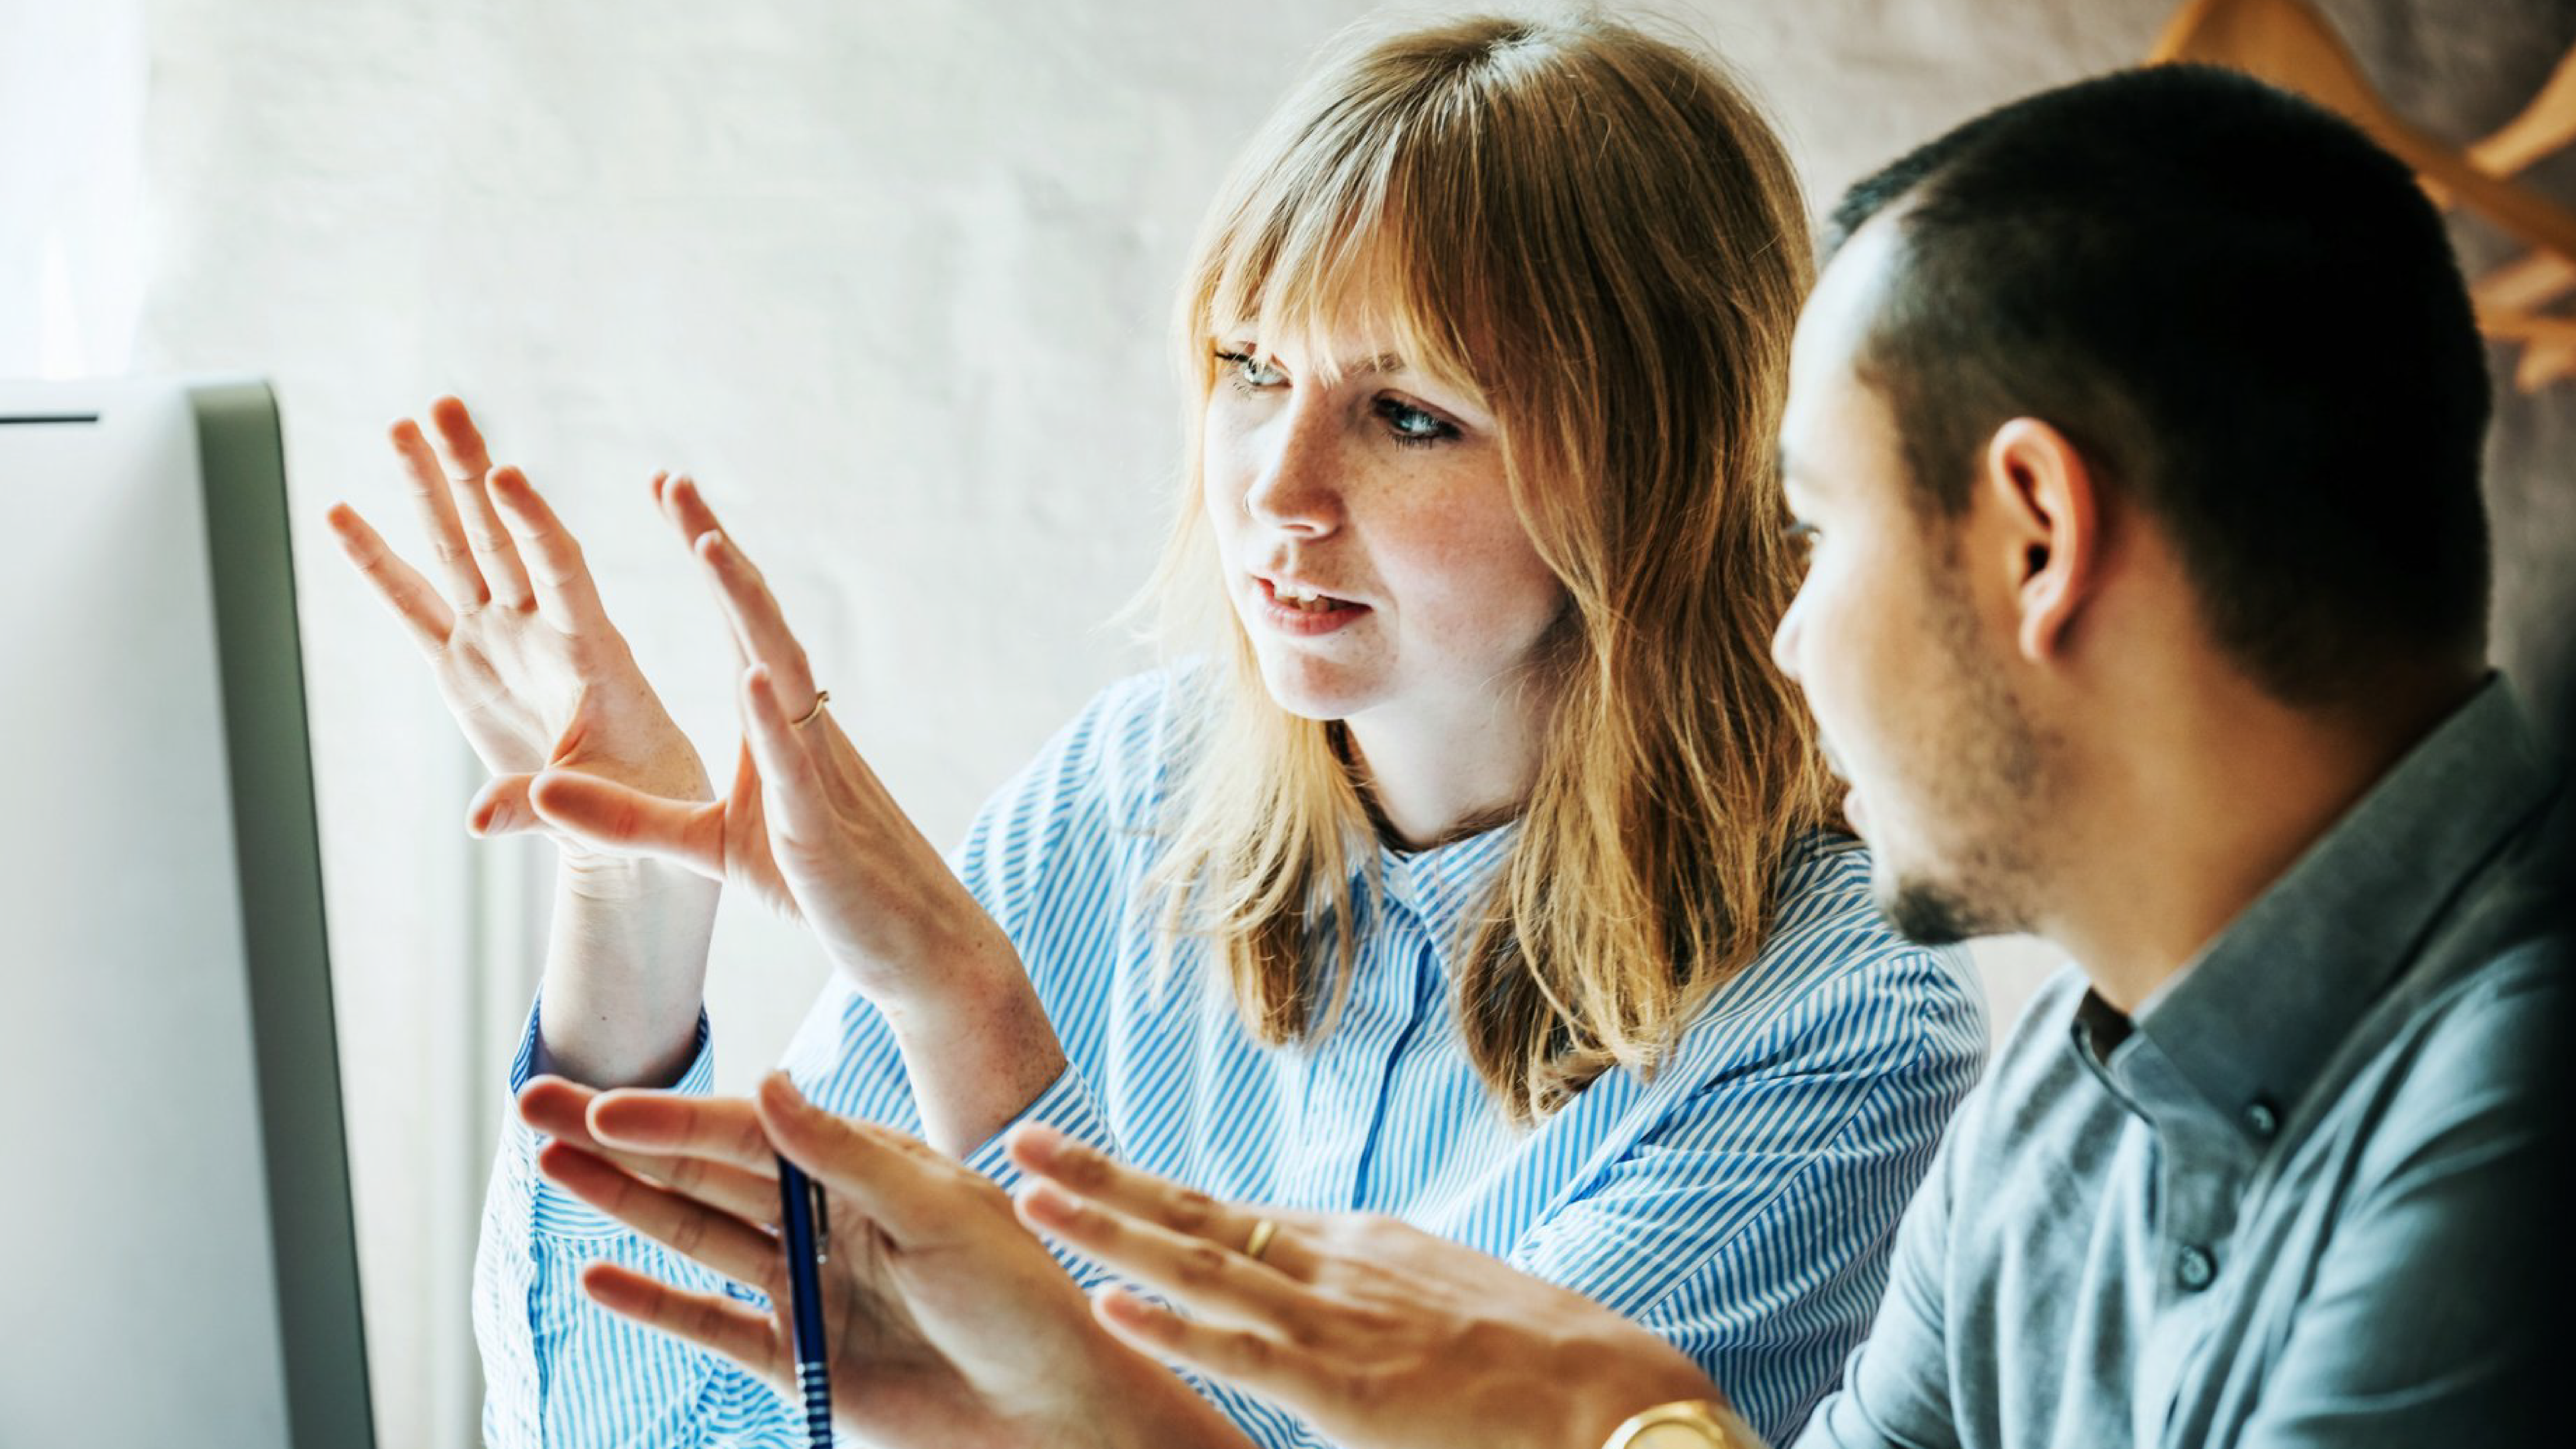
520, 1073, 1244, 1449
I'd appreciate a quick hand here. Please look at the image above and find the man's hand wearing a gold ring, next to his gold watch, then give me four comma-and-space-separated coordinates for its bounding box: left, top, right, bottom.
1010, 1127, 1718, 1449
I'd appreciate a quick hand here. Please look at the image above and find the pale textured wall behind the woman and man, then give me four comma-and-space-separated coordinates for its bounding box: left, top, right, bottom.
142, 0, 2576, 1446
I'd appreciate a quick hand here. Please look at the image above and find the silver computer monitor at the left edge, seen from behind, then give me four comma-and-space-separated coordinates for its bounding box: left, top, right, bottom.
0, 381, 374, 1449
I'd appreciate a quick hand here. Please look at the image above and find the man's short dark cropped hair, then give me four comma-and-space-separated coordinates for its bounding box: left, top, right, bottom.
1826, 67, 2488, 705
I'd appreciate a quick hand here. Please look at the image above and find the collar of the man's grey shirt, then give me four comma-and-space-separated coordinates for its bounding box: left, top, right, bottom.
2074, 677, 2553, 1143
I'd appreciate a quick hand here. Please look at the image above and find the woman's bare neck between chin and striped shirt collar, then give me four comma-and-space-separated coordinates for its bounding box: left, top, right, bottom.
1342, 690, 1543, 849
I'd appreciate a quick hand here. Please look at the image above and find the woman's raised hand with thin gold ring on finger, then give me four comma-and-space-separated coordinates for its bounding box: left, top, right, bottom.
528, 479, 1064, 1153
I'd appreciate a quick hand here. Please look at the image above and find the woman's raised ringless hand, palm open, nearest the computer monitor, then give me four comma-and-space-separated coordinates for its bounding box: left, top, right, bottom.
327, 396, 714, 860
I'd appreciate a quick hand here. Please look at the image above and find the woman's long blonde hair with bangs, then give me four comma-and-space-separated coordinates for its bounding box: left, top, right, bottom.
1154, 15, 1832, 1122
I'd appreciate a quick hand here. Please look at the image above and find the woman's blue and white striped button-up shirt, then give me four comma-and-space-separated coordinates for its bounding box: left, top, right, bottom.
474, 674, 1986, 1449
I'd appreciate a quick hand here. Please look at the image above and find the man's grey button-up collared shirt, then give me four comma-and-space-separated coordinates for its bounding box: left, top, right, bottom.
1798, 679, 2568, 1449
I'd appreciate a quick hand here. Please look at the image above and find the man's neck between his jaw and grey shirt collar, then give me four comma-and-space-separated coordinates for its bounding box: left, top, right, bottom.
2043, 677, 2478, 1014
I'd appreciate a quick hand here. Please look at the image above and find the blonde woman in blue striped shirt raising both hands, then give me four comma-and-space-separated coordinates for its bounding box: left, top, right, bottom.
335, 21, 1984, 1444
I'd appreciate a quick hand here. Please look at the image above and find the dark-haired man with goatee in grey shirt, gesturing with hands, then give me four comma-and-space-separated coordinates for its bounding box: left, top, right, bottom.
518, 70, 2568, 1449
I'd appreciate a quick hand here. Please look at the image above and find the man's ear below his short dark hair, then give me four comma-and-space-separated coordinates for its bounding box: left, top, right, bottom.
1981, 417, 2102, 664
